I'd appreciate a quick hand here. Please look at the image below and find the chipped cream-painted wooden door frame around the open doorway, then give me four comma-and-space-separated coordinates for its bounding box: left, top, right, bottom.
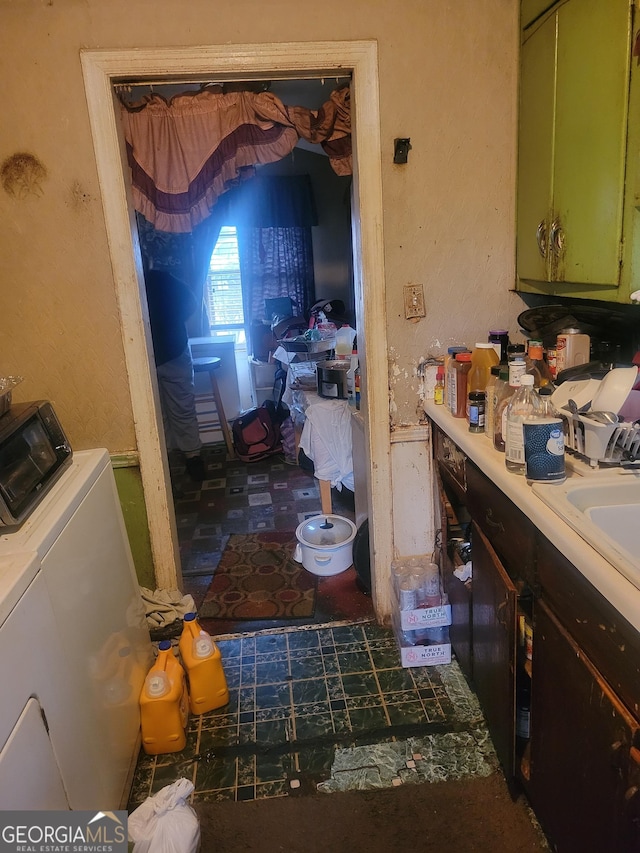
80, 40, 393, 619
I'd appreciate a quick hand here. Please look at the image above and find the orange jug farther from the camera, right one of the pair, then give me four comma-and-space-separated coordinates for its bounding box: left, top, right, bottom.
178, 613, 229, 714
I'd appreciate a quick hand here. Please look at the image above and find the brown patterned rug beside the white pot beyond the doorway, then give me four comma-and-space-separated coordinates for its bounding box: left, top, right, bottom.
198, 531, 318, 620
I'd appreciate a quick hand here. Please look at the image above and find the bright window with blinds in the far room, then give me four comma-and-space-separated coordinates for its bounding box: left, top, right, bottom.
207, 230, 246, 344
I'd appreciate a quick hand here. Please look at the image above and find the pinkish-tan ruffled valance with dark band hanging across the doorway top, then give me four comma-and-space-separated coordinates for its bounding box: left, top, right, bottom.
122, 86, 351, 233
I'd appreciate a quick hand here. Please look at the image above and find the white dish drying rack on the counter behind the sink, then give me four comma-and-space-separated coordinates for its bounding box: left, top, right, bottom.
560, 412, 640, 468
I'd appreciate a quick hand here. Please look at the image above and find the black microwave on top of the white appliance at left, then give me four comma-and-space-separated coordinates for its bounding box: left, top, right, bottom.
0, 400, 73, 531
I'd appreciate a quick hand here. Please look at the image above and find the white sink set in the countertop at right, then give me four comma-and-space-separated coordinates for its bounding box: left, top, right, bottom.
531, 473, 640, 589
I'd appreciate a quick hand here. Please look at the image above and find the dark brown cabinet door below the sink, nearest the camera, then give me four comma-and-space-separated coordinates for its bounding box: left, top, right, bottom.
528, 600, 640, 853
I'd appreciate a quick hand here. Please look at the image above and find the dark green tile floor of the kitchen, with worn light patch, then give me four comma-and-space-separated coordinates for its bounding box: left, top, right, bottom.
129, 622, 497, 809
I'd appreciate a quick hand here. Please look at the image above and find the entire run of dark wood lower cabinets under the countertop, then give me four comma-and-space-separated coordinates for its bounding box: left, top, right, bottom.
434, 418, 640, 853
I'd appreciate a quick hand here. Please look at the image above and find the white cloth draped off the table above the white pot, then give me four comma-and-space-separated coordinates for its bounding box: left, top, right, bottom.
300, 397, 355, 492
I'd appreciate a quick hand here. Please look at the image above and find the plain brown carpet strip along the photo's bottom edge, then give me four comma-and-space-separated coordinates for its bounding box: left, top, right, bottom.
194, 773, 550, 853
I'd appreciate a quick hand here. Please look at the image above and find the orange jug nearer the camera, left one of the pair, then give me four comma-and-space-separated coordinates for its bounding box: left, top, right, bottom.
140, 640, 189, 755
